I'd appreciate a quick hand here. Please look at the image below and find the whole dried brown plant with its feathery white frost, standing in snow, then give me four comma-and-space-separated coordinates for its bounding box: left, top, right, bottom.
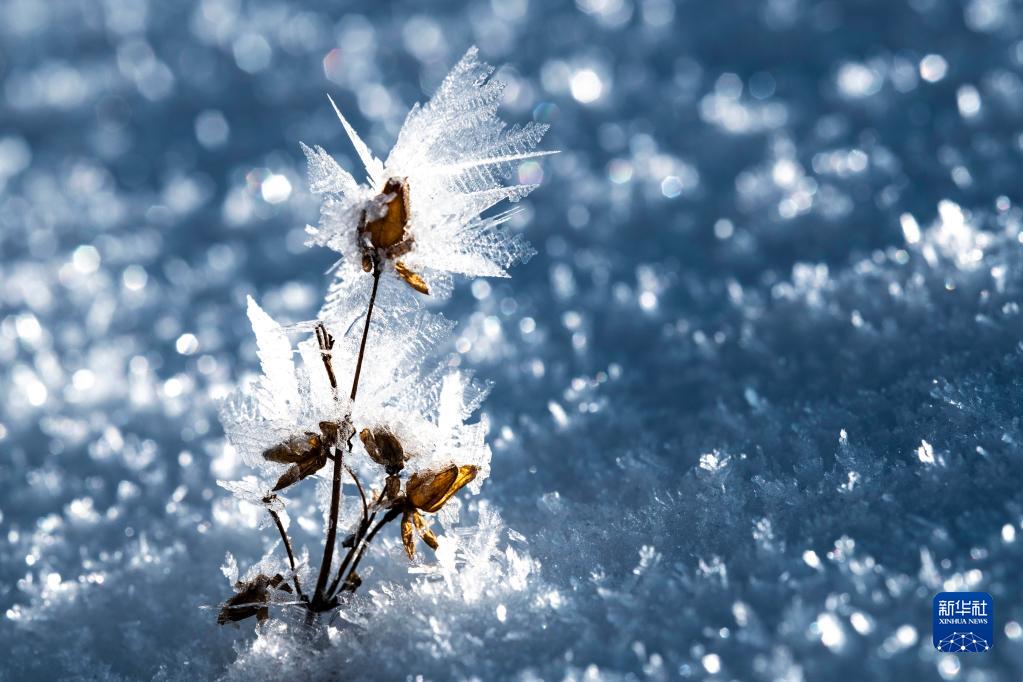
218, 48, 549, 624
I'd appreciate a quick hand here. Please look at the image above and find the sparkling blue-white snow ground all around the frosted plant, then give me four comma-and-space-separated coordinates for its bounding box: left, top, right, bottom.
0, 0, 1023, 680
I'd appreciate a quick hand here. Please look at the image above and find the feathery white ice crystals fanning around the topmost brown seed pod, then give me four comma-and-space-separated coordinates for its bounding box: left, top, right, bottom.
303, 47, 550, 292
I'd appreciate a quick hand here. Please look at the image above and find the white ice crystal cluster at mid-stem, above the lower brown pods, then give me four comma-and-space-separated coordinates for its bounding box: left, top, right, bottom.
221, 296, 490, 509
